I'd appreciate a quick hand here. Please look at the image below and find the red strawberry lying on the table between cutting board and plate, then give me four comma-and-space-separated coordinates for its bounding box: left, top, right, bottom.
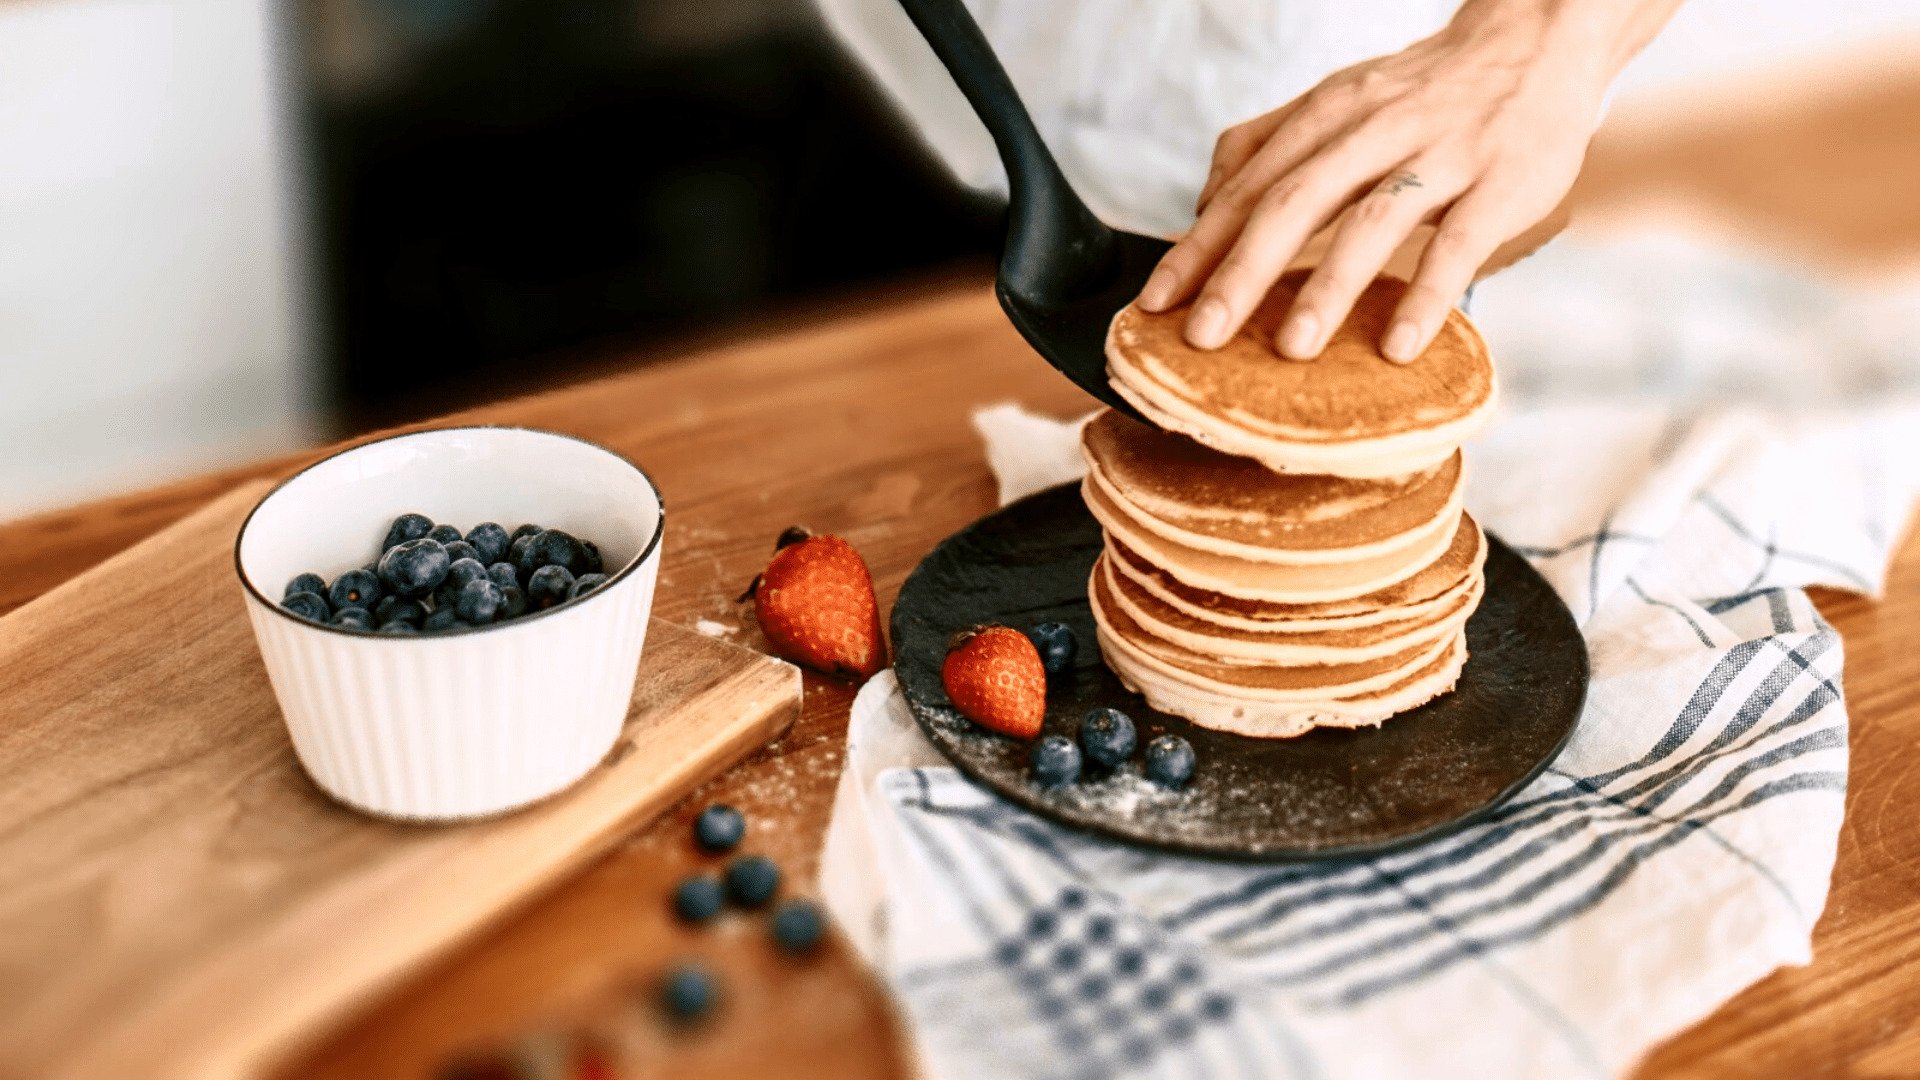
741, 528, 887, 678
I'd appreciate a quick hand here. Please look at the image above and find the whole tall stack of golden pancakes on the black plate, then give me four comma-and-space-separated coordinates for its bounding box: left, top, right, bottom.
1081, 277, 1496, 738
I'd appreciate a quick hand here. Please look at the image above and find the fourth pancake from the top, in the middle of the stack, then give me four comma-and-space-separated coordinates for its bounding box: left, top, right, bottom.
1106, 513, 1486, 630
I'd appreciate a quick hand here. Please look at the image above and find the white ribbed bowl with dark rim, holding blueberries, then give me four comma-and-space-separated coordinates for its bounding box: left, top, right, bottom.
234, 427, 666, 821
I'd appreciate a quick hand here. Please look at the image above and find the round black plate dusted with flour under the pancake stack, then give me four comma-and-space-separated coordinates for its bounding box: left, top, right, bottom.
893, 484, 1588, 861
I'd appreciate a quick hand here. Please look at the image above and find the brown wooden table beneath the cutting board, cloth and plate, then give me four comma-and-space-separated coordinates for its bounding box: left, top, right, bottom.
11, 62, 1920, 1080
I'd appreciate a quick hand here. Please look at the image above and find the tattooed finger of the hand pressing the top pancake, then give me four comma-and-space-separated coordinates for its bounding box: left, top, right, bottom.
1273, 161, 1461, 359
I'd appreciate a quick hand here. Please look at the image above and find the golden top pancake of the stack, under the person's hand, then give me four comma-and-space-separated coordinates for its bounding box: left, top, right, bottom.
1106, 271, 1498, 479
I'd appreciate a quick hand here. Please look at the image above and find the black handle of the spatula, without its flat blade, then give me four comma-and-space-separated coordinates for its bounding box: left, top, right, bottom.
900, 0, 1116, 304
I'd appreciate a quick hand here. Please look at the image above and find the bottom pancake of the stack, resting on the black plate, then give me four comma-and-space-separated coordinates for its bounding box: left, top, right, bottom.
1096, 628, 1467, 738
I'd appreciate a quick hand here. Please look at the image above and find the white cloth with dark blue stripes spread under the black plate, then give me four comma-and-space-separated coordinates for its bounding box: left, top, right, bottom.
822, 244, 1920, 1080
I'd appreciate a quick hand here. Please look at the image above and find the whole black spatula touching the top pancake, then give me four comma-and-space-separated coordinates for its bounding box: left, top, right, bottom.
900, 0, 1171, 419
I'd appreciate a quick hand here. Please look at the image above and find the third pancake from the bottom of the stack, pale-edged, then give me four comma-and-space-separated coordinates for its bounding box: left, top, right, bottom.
1096, 555, 1484, 665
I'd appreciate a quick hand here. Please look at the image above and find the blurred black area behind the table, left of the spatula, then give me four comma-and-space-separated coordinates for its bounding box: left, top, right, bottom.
300, 0, 1002, 432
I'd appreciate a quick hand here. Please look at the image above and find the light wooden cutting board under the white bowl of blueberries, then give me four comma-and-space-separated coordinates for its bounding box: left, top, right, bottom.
0, 482, 801, 1080
